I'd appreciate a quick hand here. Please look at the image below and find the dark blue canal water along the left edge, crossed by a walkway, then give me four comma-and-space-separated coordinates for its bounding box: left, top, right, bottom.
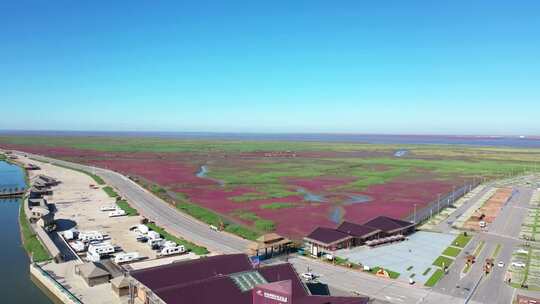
0, 161, 52, 304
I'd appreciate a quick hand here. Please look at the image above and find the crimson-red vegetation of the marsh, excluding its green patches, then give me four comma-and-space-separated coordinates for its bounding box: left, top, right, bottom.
0, 146, 466, 239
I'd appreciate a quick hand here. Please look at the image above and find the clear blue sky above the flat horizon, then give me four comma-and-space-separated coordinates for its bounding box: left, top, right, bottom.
0, 0, 540, 135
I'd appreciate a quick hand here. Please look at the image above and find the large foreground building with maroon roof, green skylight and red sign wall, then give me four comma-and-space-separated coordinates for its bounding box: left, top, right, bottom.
129, 254, 368, 304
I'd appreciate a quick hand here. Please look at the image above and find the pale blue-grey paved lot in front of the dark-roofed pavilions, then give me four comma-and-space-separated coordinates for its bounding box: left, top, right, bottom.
336, 231, 456, 284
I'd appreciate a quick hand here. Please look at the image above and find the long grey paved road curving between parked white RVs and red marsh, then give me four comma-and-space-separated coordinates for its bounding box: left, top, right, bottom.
18, 152, 250, 253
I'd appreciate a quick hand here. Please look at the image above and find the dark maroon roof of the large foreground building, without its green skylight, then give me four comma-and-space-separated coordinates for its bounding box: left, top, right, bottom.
131, 254, 368, 304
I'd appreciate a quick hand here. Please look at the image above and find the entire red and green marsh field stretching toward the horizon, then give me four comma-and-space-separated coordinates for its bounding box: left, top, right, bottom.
0, 137, 532, 239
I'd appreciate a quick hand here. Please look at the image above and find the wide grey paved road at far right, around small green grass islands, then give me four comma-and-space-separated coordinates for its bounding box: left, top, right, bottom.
435, 188, 532, 303
